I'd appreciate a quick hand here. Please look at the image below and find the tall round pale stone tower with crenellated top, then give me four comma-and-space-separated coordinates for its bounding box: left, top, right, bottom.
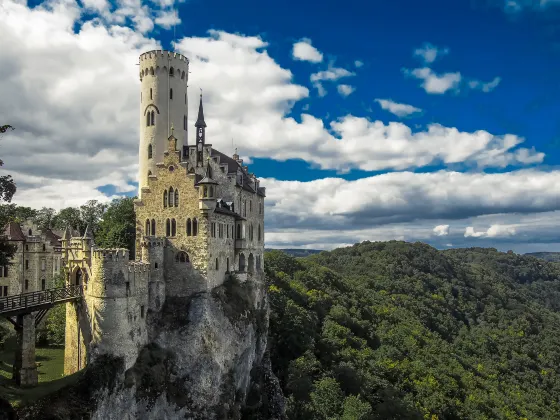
138, 50, 189, 198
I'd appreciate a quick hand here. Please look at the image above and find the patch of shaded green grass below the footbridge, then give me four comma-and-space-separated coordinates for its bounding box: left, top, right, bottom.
0, 336, 79, 407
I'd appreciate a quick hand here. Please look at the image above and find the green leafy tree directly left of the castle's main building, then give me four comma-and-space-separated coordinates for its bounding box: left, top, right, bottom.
95, 197, 136, 258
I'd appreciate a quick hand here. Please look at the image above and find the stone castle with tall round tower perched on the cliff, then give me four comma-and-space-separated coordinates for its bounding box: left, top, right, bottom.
60, 50, 265, 374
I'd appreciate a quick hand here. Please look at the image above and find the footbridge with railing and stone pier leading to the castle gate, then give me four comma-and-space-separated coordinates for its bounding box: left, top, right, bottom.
0, 285, 83, 386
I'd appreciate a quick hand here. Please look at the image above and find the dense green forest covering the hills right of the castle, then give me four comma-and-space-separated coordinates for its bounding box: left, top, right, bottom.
265, 241, 560, 420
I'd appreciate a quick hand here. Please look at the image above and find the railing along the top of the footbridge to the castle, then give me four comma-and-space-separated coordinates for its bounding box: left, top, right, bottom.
0, 285, 82, 313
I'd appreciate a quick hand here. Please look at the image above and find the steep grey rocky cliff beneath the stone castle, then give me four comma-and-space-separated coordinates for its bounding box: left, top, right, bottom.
19, 279, 285, 420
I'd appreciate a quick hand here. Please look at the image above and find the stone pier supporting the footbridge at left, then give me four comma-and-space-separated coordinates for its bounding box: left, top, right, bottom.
13, 313, 39, 386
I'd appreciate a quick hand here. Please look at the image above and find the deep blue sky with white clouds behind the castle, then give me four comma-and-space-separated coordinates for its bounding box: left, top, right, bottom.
0, 0, 560, 252
